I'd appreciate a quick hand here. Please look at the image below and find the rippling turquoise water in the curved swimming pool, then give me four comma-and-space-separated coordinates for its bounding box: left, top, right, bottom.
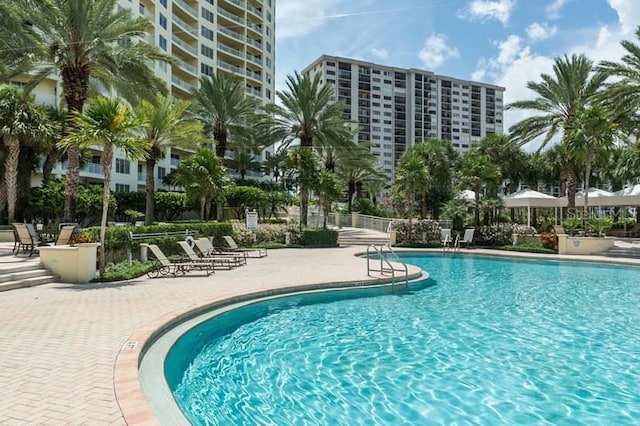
165, 255, 640, 425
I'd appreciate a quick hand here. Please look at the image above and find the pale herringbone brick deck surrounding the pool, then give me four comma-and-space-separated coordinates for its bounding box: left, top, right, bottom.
0, 238, 640, 425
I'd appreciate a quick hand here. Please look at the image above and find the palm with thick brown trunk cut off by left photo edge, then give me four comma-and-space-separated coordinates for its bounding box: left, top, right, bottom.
0, 85, 51, 223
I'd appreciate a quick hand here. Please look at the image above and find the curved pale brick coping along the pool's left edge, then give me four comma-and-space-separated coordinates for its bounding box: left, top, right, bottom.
113, 262, 429, 425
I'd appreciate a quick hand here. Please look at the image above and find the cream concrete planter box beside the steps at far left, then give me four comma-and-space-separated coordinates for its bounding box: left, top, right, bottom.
38, 243, 100, 284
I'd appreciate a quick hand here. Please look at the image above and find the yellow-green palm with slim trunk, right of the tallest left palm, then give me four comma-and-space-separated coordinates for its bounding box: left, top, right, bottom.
134, 95, 204, 225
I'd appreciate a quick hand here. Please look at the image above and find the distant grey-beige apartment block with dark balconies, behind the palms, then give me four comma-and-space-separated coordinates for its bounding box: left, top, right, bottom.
302, 55, 505, 179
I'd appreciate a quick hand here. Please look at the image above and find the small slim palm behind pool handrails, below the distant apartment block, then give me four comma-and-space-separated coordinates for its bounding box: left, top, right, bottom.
393, 151, 430, 239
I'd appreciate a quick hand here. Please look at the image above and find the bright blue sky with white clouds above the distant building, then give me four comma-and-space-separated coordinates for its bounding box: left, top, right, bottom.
276, 0, 640, 151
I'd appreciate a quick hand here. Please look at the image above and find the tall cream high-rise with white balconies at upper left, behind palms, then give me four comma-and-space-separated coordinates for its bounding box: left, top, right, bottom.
18, 0, 275, 191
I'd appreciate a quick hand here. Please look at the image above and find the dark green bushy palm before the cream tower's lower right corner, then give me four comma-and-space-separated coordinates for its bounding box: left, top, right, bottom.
193, 74, 258, 158
